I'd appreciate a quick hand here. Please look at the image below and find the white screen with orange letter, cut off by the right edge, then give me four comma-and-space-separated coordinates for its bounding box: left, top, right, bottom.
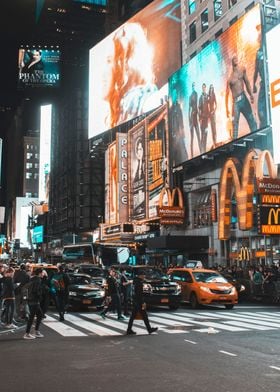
266, 25, 280, 164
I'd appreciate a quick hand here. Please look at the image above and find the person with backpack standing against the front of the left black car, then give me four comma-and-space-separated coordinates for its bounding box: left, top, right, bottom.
50, 265, 70, 321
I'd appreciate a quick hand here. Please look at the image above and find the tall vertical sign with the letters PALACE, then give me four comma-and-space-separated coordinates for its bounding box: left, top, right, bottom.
116, 133, 128, 222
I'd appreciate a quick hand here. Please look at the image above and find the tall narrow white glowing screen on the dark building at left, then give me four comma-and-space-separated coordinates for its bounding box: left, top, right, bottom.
39, 105, 52, 203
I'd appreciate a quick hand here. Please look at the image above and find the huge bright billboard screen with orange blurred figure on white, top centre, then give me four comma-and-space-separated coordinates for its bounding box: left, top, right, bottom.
89, 0, 181, 138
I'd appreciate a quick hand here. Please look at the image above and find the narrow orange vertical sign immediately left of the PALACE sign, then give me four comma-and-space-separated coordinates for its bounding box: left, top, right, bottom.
108, 142, 118, 223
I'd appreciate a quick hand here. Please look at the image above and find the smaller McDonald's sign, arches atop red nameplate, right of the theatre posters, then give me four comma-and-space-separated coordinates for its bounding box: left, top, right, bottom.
157, 187, 185, 225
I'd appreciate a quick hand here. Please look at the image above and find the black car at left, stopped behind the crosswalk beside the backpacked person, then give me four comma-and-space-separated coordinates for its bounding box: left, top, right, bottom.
68, 272, 105, 309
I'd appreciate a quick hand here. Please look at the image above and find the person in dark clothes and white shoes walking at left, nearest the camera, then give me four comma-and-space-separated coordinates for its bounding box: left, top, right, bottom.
23, 268, 44, 340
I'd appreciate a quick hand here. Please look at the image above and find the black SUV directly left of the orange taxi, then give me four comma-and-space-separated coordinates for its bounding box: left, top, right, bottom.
112, 265, 181, 310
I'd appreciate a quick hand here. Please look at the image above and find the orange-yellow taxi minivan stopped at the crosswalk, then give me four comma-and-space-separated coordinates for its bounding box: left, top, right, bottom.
168, 267, 238, 309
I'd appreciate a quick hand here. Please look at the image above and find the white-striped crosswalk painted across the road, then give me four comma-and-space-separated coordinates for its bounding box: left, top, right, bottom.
43, 310, 280, 337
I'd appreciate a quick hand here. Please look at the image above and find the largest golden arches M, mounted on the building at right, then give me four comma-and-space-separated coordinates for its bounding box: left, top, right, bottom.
219, 149, 277, 240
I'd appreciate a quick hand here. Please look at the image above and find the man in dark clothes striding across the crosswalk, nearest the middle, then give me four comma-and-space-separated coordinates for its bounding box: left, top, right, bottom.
126, 275, 158, 335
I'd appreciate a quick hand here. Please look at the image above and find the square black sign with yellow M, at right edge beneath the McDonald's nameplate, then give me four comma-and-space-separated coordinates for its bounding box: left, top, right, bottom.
258, 206, 280, 235
